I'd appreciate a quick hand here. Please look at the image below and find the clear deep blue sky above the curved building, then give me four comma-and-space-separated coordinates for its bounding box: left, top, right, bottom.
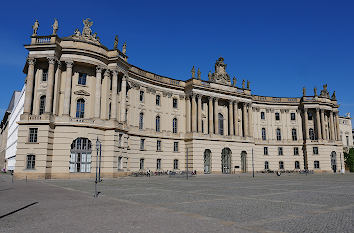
0, 0, 354, 123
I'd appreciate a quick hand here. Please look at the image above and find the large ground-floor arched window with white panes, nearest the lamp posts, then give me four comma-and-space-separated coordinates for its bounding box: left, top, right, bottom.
70, 138, 92, 172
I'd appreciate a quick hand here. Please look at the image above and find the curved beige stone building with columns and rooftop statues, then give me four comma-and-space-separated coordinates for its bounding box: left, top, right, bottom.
15, 19, 344, 178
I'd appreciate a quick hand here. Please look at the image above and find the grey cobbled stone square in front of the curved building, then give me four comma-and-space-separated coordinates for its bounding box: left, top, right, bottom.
0, 174, 354, 233
